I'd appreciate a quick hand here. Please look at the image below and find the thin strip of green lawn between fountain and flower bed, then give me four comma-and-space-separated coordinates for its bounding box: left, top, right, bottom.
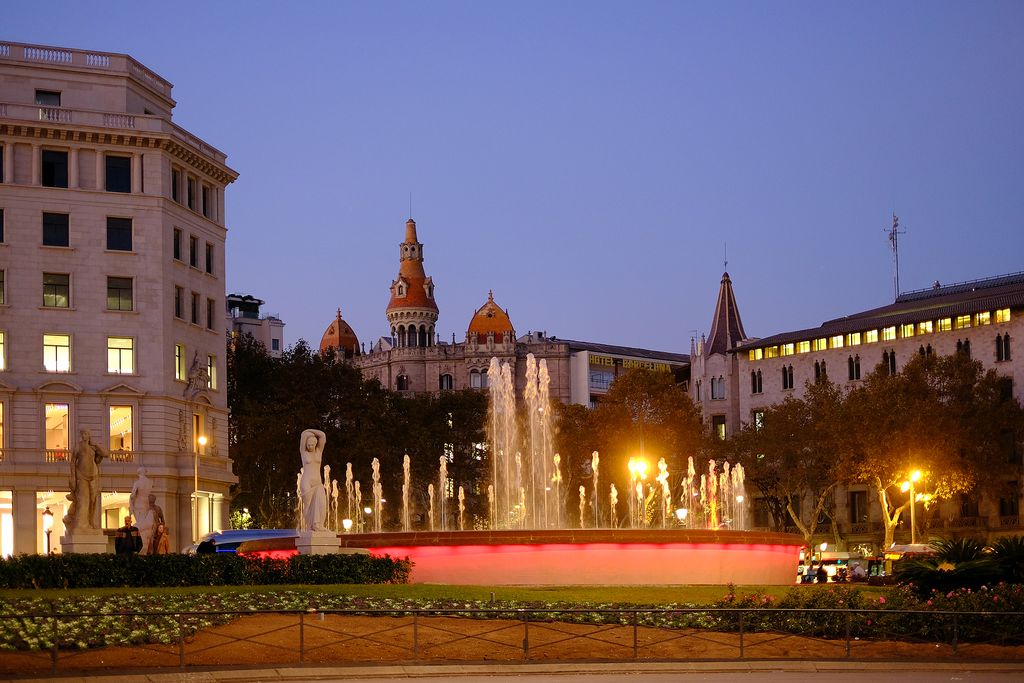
0, 584, 889, 606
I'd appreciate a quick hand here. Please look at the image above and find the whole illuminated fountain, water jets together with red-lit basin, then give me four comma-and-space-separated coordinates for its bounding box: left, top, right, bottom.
309, 354, 803, 585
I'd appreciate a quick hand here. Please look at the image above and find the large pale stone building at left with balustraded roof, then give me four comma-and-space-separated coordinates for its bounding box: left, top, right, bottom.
0, 43, 237, 555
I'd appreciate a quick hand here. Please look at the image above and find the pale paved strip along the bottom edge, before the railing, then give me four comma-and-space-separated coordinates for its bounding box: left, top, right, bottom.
17, 660, 1024, 683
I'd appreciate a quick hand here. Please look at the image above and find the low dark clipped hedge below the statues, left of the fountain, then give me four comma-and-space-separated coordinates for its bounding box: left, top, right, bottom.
0, 553, 413, 588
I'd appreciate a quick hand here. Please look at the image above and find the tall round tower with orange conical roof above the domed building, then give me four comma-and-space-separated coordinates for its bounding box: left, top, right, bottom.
387, 218, 438, 347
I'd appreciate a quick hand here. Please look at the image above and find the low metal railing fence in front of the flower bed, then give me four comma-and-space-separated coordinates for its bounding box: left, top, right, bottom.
0, 606, 1024, 677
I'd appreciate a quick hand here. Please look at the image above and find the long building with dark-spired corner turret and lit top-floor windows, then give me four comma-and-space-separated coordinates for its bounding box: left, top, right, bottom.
689, 273, 1024, 550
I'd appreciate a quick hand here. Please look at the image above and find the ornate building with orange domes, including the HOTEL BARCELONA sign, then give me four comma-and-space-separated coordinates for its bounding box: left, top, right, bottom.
321, 218, 689, 405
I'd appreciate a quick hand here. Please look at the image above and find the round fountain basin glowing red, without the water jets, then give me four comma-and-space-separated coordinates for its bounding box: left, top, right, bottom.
331, 528, 804, 586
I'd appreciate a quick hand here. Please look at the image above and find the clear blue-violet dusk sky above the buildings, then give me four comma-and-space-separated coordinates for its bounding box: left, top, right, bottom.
9, 0, 1024, 352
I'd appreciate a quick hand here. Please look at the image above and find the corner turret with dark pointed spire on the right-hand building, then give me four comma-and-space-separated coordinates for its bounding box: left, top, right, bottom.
690, 272, 746, 439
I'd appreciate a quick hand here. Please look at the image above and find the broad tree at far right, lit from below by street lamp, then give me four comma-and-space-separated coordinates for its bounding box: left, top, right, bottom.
841, 353, 1022, 548
